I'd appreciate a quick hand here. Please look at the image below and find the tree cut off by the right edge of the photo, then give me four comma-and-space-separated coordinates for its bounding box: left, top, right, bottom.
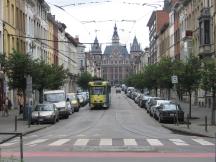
202, 60, 216, 125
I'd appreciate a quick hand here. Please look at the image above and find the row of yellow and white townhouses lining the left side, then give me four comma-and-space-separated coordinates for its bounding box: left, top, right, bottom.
0, 0, 85, 109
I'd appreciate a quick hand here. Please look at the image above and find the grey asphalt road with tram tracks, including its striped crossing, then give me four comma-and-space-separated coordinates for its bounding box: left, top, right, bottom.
1, 88, 215, 162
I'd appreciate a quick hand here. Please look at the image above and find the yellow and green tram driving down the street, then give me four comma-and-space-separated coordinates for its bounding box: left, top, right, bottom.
88, 81, 111, 109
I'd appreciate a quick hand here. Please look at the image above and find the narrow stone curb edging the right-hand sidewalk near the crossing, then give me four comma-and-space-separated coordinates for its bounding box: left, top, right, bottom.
161, 124, 215, 138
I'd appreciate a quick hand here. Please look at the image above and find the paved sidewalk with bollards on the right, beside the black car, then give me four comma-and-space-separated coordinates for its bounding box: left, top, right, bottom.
162, 102, 216, 138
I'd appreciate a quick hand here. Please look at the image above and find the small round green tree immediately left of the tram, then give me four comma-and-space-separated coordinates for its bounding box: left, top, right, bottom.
77, 72, 92, 90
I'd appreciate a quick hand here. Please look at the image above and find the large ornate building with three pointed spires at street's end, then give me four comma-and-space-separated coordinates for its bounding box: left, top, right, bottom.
90, 24, 142, 85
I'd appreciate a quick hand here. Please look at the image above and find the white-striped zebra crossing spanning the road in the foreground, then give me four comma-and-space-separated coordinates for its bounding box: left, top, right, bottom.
0, 138, 215, 148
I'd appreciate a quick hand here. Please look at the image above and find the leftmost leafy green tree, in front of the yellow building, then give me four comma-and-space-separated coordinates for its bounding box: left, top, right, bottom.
5, 51, 33, 108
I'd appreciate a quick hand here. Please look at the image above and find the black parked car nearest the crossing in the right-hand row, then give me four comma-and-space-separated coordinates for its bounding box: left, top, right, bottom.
155, 103, 184, 123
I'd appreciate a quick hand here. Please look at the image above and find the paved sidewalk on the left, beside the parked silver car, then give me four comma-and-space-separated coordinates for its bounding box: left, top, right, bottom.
0, 109, 49, 142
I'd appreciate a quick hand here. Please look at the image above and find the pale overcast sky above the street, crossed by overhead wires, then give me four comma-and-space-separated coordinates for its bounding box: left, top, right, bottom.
46, 0, 163, 51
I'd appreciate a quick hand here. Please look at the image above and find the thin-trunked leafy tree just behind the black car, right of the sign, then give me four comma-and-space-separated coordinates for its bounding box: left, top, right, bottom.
178, 55, 201, 118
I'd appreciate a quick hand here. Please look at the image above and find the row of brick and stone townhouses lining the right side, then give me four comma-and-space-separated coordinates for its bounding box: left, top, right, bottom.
146, 0, 216, 107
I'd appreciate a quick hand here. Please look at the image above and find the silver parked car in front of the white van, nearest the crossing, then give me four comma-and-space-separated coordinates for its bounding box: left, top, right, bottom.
31, 103, 59, 124
